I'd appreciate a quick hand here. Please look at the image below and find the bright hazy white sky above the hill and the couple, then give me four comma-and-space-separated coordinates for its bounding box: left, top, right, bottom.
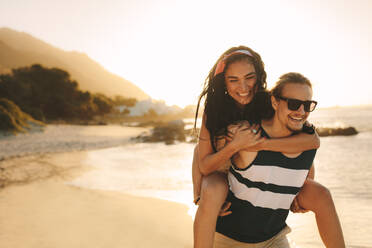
0, 0, 372, 107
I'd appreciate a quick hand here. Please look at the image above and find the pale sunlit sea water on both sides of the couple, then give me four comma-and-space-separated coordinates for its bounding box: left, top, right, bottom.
61, 106, 372, 248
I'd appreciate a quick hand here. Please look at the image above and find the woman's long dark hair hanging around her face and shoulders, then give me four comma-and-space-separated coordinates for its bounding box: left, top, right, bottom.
194, 46, 267, 151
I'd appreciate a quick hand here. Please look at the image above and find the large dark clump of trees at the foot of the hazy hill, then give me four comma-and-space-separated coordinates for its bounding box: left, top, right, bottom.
0, 64, 135, 124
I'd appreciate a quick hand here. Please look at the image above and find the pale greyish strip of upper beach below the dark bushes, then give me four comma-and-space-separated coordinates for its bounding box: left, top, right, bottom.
0, 124, 149, 162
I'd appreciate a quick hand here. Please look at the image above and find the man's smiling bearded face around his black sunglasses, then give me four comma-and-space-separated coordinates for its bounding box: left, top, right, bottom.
273, 83, 313, 132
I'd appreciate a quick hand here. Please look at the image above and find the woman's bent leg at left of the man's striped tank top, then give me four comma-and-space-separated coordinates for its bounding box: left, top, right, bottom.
194, 172, 228, 248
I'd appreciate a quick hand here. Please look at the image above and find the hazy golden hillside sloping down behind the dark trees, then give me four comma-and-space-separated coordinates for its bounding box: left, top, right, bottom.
0, 28, 149, 100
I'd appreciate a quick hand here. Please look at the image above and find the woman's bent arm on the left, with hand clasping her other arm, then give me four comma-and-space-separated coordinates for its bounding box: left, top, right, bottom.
199, 116, 263, 175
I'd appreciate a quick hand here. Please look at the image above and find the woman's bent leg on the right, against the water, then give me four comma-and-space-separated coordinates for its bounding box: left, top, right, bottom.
297, 179, 345, 248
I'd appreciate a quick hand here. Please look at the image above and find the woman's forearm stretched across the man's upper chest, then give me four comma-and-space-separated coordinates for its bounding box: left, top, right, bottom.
258, 132, 320, 153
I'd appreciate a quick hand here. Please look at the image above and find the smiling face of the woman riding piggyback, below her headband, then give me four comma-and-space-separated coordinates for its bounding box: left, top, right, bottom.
225, 60, 257, 107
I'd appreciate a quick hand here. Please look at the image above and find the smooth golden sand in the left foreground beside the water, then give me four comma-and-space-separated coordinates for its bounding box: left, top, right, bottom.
0, 148, 192, 248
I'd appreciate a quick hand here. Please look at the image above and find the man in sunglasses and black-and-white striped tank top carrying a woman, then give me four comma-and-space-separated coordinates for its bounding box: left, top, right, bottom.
215, 73, 317, 248
